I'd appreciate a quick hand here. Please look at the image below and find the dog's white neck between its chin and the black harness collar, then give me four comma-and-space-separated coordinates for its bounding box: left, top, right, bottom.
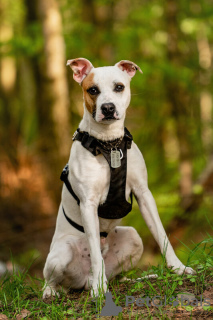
79, 108, 125, 141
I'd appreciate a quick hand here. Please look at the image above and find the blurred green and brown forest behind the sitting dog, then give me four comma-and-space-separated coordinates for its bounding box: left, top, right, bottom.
0, 0, 213, 275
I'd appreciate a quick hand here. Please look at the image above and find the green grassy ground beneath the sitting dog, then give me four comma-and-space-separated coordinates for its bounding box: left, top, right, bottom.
0, 235, 213, 320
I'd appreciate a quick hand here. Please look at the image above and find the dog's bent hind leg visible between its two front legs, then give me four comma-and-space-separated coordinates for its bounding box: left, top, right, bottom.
104, 227, 143, 279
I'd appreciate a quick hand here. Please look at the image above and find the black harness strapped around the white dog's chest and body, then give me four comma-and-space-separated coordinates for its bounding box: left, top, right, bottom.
61, 128, 133, 237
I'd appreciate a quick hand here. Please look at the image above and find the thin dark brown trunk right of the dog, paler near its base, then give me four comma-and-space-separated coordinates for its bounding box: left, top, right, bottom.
165, 0, 192, 202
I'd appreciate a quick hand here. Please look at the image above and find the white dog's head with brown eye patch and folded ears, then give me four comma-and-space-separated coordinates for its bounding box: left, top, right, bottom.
67, 58, 142, 124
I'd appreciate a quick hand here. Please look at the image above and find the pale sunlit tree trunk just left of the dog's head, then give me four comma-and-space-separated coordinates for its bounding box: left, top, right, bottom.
37, 0, 71, 158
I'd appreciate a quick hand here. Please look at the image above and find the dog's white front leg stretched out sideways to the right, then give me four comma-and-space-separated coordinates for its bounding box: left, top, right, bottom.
134, 188, 194, 274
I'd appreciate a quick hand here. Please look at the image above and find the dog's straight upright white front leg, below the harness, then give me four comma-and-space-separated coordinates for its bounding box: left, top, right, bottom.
80, 201, 107, 296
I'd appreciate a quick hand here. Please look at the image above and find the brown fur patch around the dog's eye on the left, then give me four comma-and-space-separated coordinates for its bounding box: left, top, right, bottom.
82, 73, 100, 115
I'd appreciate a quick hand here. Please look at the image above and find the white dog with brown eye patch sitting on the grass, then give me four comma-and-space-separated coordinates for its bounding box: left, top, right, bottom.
43, 58, 194, 298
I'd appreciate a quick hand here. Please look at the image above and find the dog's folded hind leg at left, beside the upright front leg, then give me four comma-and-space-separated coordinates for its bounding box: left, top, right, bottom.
43, 236, 90, 299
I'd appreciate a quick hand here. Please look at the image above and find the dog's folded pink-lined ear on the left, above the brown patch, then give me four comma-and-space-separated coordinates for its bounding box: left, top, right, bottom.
67, 58, 94, 83
